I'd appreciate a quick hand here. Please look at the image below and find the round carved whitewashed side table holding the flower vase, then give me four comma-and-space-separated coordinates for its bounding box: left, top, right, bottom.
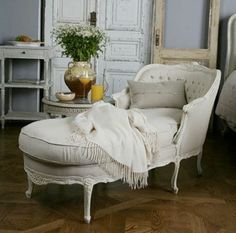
42, 96, 114, 118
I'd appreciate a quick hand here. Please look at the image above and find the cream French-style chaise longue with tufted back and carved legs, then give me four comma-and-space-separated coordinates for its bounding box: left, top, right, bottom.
19, 64, 221, 223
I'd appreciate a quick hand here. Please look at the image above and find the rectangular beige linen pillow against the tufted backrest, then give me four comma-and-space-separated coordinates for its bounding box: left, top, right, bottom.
128, 80, 186, 108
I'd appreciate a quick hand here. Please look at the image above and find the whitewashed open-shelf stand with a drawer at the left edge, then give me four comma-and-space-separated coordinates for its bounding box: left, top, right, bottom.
0, 46, 53, 128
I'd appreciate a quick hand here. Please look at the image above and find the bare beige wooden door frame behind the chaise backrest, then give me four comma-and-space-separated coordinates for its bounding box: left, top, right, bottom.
152, 0, 220, 68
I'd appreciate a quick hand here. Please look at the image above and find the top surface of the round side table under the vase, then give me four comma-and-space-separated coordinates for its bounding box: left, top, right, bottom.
42, 96, 115, 108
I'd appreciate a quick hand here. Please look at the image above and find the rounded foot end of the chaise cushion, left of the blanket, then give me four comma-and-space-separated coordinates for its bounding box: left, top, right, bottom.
19, 117, 96, 165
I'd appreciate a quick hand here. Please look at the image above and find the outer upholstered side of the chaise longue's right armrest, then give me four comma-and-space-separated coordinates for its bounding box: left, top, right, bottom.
173, 74, 220, 157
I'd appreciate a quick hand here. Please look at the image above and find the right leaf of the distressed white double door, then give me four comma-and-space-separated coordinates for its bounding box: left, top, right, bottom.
97, 0, 152, 94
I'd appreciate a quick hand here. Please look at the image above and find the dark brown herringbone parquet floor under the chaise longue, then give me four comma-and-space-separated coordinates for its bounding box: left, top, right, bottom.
0, 123, 236, 233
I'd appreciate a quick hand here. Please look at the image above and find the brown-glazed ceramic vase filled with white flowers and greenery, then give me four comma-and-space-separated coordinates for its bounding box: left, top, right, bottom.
53, 24, 105, 98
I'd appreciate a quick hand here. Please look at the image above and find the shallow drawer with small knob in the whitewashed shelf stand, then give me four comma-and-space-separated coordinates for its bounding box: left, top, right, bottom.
4, 48, 45, 59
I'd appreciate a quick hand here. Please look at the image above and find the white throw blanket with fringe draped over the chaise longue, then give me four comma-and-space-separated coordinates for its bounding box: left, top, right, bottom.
71, 101, 157, 188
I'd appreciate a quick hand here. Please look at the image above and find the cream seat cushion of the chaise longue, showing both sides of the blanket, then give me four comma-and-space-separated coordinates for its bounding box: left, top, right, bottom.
19, 108, 182, 165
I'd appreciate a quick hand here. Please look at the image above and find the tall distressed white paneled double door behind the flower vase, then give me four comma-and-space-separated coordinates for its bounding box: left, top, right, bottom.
45, 0, 153, 94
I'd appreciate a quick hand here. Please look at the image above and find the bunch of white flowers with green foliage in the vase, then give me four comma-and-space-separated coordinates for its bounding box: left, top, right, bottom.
52, 24, 105, 61
